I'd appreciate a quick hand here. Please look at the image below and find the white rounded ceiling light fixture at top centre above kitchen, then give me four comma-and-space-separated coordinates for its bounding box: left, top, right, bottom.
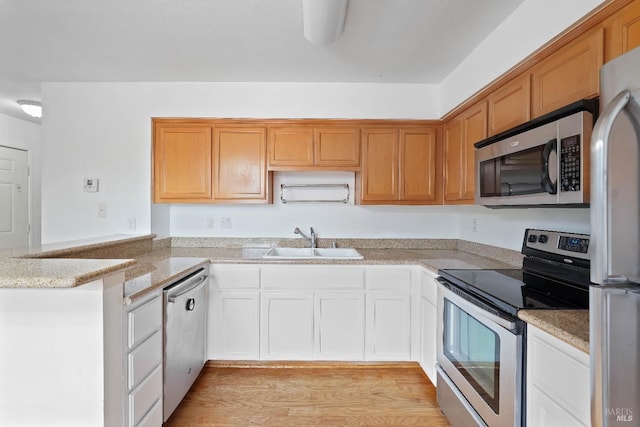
302, 0, 349, 45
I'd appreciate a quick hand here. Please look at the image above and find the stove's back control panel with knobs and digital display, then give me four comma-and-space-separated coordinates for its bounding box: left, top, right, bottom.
523, 228, 589, 260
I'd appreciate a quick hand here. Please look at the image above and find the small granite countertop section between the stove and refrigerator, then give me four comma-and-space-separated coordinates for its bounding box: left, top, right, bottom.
518, 310, 589, 354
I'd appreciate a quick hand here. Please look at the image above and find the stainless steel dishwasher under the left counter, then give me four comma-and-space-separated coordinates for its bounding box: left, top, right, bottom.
163, 267, 209, 421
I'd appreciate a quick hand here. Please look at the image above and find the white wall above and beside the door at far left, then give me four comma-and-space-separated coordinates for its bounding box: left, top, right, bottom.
0, 114, 42, 245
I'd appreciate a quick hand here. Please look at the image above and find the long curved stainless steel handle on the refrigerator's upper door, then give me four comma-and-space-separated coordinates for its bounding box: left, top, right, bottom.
591, 90, 631, 285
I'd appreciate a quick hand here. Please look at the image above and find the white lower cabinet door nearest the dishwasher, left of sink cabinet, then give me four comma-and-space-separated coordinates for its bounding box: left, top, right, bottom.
208, 291, 260, 360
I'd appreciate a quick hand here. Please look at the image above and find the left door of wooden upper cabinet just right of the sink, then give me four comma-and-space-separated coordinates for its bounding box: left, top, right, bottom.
360, 128, 398, 203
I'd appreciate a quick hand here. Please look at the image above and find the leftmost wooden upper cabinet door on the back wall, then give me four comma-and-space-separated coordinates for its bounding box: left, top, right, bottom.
153, 124, 212, 203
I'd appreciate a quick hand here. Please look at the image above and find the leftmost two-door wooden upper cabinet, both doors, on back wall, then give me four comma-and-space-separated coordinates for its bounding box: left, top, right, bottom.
153, 120, 271, 203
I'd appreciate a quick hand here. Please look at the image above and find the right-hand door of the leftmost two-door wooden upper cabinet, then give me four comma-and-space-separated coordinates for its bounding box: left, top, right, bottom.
214, 127, 269, 201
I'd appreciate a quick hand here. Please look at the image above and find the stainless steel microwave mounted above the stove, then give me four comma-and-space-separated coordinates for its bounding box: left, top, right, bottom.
475, 100, 597, 207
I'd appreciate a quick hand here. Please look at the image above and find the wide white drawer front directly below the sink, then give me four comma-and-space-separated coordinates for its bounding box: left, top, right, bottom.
262, 266, 364, 290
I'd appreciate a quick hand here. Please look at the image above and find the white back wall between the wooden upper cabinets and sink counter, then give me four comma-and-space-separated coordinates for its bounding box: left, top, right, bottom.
171, 172, 459, 239
